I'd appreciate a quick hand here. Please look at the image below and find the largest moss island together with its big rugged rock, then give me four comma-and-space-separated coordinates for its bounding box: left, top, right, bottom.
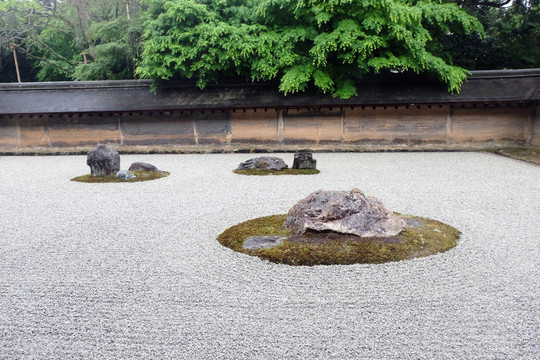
218, 188, 460, 265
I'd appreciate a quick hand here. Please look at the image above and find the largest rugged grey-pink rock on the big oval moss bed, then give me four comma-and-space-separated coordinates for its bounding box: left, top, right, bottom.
283, 188, 407, 237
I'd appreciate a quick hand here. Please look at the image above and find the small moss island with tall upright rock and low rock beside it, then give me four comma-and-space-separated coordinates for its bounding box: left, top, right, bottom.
71, 144, 169, 182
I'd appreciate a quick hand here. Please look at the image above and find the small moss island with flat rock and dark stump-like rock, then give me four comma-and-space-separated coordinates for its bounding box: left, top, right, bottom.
234, 152, 319, 175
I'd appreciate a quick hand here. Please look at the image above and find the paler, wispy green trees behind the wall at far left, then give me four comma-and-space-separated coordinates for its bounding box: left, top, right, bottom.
0, 0, 142, 81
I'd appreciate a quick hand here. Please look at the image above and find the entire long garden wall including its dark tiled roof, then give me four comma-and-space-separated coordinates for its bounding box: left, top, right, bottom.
0, 69, 540, 153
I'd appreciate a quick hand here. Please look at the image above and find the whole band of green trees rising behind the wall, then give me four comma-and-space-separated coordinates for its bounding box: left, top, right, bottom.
0, 0, 540, 86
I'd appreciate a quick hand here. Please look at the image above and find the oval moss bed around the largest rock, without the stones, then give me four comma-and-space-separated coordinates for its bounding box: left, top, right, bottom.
217, 215, 461, 266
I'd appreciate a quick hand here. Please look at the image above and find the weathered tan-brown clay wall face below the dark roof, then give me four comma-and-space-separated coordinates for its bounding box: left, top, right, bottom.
0, 106, 540, 152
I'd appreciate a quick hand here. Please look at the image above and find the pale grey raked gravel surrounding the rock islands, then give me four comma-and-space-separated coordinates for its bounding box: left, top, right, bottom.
0, 153, 540, 359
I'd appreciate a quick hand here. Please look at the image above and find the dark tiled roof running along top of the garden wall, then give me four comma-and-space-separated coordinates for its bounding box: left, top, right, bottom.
0, 69, 540, 115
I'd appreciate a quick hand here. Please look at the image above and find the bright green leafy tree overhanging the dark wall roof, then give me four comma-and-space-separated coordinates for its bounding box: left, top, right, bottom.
137, 0, 482, 98
